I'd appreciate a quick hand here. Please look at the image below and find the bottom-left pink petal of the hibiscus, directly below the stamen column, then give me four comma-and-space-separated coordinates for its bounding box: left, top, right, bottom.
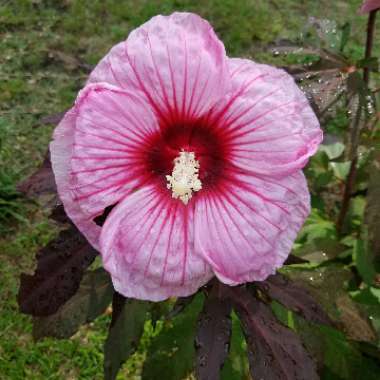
100, 184, 212, 301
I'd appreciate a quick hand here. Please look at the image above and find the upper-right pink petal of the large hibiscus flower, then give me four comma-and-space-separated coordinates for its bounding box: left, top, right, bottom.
213, 59, 322, 175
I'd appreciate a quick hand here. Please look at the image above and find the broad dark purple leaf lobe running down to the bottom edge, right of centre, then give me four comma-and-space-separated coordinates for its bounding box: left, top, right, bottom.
231, 287, 319, 380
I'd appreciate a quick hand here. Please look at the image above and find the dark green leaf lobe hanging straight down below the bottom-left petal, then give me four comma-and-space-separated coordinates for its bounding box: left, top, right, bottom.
104, 292, 151, 380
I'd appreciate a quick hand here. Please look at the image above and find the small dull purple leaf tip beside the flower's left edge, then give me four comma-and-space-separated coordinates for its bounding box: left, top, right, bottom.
17, 153, 57, 198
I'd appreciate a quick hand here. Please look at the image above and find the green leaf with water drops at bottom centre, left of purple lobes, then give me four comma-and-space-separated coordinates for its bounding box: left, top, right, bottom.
142, 294, 203, 380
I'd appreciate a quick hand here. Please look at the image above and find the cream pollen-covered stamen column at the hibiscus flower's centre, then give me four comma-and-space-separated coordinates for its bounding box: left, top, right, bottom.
166, 151, 202, 205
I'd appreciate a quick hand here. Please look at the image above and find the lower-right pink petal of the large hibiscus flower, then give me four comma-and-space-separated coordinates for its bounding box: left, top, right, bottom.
195, 171, 310, 285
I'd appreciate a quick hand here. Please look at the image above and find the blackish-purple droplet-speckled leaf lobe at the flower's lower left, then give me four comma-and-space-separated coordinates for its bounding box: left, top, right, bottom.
18, 226, 98, 316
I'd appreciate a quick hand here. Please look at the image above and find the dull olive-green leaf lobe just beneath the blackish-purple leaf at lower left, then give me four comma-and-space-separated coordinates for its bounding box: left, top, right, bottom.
33, 268, 113, 339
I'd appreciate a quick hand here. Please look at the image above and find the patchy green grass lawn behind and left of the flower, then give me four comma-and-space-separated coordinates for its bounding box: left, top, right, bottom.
0, 0, 372, 380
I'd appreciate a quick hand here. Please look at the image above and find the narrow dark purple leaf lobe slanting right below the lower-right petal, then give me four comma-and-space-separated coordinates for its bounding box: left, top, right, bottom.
255, 273, 333, 326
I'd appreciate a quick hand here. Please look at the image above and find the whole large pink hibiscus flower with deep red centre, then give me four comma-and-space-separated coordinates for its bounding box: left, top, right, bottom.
50, 13, 322, 301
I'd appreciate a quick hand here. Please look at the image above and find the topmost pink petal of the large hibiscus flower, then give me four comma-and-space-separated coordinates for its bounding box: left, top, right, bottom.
89, 13, 228, 122
